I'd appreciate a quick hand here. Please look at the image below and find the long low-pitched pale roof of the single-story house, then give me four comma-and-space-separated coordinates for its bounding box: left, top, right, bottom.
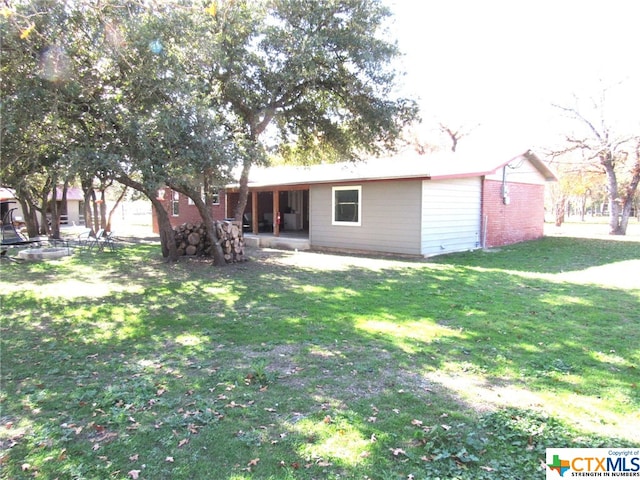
242, 149, 557, 188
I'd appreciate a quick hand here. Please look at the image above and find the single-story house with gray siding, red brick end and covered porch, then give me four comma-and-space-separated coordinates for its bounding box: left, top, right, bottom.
159, 150, 557, 256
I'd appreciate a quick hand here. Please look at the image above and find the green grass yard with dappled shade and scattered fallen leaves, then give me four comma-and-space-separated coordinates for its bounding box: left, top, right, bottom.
0, 233, 640, 480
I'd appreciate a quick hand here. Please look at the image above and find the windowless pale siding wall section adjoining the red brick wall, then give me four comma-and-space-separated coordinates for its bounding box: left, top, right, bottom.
421, 177, 482, 256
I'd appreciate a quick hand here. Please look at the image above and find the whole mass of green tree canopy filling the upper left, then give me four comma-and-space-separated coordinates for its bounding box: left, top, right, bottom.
0, 0, 417, 258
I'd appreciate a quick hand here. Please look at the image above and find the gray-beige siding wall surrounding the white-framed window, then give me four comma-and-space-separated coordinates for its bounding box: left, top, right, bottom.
309, 180, 422, 255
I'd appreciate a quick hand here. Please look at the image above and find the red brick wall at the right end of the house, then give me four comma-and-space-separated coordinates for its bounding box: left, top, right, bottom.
482, 180, 544, 247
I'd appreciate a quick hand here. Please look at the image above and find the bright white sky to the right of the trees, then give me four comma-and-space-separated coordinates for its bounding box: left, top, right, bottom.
386, 0, 640, 154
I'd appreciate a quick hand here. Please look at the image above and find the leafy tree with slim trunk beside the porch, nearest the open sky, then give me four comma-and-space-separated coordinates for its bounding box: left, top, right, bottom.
192, 0, 417, 218
